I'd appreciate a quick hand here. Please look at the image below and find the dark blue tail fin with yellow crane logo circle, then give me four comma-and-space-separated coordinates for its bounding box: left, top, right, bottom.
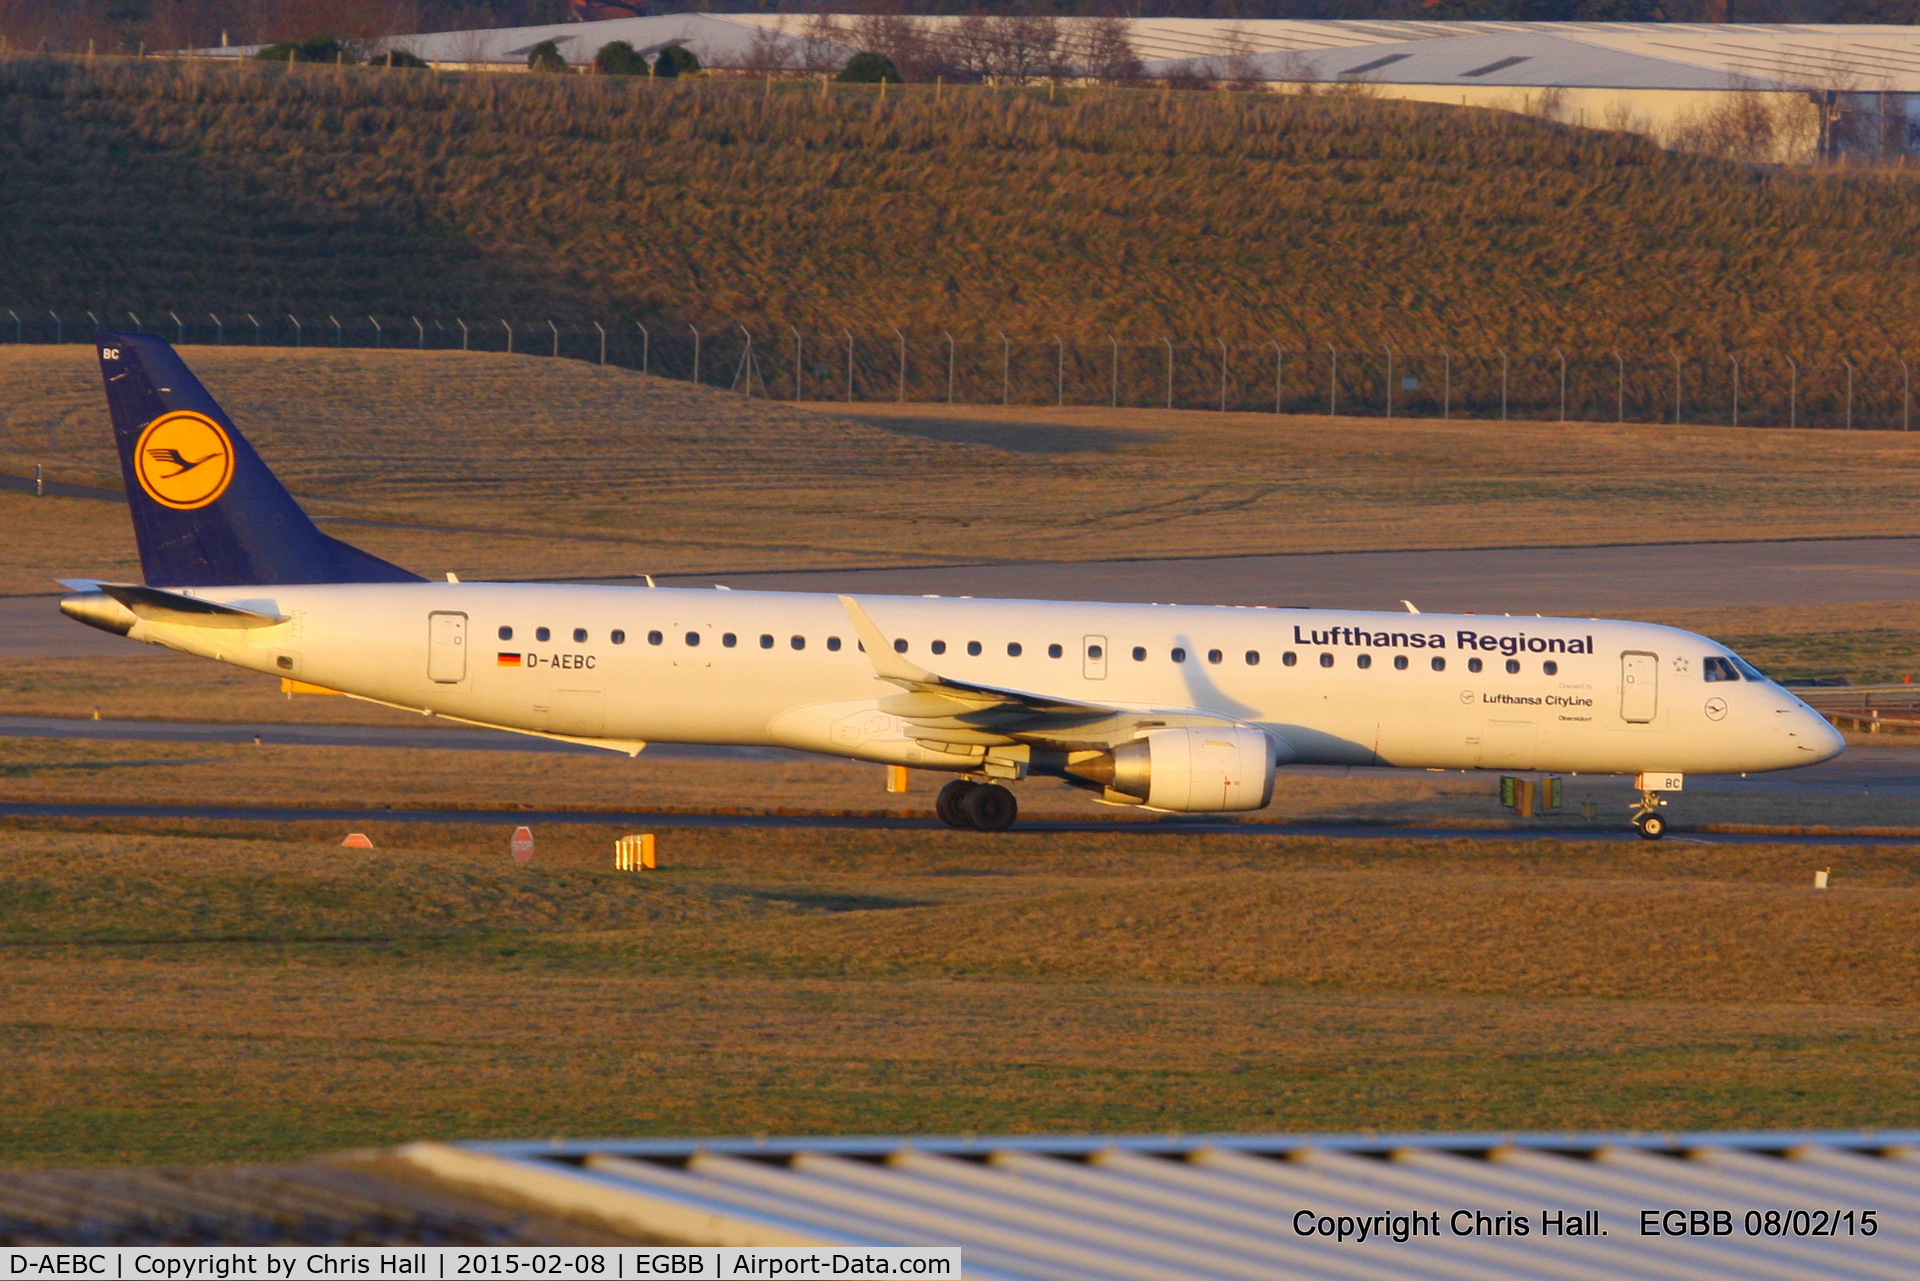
94, 334, 419, 588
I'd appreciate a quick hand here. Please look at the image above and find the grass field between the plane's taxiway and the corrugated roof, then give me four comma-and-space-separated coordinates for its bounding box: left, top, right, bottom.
0, 824, 1920, 1164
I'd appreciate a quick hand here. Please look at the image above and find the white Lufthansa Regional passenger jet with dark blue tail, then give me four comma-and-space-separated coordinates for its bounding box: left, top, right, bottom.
60, 334, 1843, 837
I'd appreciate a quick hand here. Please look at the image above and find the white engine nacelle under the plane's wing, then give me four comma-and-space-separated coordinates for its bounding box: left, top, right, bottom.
1098, 726, 1290, 814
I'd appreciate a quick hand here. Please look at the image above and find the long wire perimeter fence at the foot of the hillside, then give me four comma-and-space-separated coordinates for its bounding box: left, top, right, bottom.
11, 307, 1912, 430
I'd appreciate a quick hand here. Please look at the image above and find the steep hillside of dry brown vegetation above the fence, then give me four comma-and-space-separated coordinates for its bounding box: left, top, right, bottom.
0, 58, 1920, 376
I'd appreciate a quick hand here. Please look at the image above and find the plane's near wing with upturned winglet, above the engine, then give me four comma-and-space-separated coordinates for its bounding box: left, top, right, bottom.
839, 595, 1238, 745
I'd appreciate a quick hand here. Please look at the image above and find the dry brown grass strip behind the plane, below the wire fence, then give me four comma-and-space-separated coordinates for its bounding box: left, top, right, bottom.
11, 348, 1920, 592
